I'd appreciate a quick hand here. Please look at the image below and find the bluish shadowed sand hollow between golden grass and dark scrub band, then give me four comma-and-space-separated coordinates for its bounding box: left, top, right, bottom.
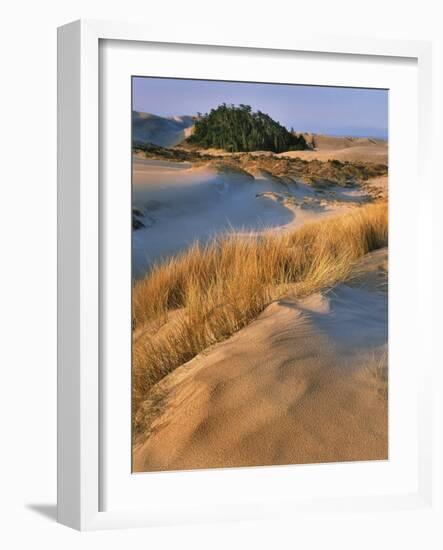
132, 156, 367, 277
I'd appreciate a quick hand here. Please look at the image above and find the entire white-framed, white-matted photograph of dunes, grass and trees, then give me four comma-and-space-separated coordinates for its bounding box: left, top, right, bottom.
58, 21, 433, 530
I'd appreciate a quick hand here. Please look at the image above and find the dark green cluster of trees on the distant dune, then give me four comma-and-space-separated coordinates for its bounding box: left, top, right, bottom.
187, 103, 309, 153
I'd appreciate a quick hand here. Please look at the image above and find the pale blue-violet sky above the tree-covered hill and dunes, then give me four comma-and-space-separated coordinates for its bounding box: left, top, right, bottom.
133, 77, 388, 138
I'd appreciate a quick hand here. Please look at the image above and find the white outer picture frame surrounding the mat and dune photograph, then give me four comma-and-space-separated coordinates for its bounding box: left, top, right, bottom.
58, 21, 433, 530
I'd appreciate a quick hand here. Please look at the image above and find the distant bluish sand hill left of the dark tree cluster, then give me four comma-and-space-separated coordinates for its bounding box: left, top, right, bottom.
132, 111, 194, 147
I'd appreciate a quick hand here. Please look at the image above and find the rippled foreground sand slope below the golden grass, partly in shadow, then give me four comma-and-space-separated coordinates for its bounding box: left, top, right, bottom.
133, 249, 388, 472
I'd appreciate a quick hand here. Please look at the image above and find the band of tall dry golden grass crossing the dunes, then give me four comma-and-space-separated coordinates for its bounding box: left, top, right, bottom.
132, 203, 388, 434
